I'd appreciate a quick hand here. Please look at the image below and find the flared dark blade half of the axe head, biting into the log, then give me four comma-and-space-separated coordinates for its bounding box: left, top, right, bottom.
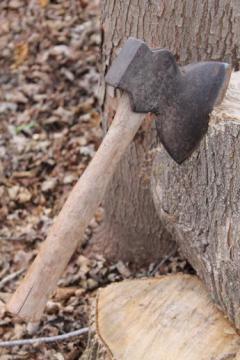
156, 62, 231, 164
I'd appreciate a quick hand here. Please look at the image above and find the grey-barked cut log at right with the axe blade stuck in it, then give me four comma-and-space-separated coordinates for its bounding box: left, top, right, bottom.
152, 72, 240, 329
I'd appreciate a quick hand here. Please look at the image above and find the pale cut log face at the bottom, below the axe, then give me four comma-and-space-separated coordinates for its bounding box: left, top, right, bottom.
85, 274, 240, 360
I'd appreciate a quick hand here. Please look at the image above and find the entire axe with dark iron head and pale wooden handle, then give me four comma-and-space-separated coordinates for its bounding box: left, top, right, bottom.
7, 38, 231, 321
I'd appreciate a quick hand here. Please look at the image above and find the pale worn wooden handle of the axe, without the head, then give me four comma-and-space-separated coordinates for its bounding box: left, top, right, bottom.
7, 95, 144, 321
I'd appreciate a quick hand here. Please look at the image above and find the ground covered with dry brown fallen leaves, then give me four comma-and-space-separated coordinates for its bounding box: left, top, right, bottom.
0, 0, 189, 360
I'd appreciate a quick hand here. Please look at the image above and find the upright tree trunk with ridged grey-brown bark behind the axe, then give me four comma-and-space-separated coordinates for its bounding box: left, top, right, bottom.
93, 0, 240, 263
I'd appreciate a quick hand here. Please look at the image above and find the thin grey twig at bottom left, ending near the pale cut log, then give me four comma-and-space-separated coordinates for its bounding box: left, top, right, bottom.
0, 328, 89, 347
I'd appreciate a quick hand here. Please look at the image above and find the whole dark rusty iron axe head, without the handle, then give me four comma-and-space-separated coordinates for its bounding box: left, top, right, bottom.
105, 38, 231, 164
